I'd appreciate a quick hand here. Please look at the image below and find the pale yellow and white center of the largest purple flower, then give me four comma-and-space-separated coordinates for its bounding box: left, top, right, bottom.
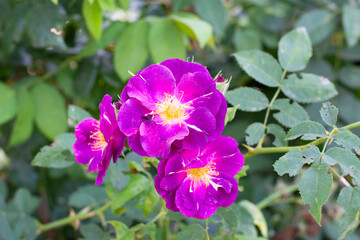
155, 93, 192, 126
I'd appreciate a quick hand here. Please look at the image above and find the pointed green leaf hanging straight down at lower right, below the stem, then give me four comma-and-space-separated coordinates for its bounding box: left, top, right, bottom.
299, 164, 332, 225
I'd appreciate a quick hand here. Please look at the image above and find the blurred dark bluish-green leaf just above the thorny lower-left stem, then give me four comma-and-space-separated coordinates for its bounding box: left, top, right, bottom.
69, 185, 109, 208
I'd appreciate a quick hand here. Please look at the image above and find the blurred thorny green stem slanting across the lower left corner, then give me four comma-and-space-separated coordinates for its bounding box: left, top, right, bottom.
39, 201, 112, 233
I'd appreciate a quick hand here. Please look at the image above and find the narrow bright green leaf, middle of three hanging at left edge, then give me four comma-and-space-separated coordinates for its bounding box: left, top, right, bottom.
9, 88, 35, 146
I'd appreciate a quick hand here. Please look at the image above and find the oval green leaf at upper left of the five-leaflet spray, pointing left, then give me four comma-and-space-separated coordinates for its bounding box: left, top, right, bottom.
234, 50, 281, 87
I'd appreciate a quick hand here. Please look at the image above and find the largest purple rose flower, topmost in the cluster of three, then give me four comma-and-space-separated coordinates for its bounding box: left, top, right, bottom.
118, 59, 227, 158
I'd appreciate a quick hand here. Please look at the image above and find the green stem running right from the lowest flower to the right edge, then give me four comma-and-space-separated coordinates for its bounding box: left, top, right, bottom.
244, 121, 360, 159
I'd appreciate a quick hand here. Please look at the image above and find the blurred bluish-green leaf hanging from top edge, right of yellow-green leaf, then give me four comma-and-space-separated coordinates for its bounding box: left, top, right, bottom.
195, 0, 227, 36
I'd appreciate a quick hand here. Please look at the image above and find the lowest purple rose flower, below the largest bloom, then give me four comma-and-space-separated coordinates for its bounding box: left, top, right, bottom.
155, 136, 244, 219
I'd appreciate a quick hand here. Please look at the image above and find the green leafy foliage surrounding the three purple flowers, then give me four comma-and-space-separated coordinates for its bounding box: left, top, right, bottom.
0, 0, 360, 240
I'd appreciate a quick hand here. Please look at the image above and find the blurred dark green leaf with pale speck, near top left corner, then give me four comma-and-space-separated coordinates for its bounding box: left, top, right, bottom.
25, 3, 67, 50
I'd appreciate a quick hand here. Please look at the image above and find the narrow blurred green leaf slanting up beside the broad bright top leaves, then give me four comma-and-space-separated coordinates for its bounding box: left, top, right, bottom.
79, 21, 125, 57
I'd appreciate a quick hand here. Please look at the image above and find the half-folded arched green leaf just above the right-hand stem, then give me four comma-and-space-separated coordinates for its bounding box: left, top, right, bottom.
286, 121, 327, 140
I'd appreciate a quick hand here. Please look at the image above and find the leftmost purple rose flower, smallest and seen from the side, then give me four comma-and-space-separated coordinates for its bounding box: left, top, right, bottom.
73, 94, 126, 185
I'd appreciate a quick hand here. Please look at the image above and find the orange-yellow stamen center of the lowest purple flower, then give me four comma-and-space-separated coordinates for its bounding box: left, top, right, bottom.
186, 163, 219, 190
